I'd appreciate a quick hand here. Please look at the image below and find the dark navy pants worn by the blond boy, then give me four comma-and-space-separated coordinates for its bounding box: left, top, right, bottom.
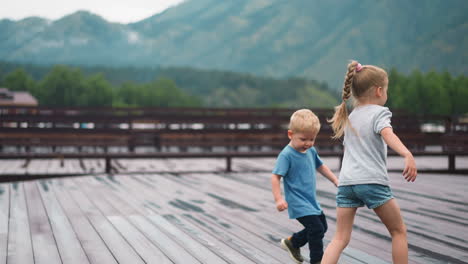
291, 212, 328, 263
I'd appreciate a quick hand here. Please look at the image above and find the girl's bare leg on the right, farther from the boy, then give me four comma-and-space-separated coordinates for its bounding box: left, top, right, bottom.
374, 199, 408, 264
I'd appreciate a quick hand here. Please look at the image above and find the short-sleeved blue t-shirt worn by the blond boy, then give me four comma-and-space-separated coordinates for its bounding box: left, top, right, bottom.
273, 145, 323, 219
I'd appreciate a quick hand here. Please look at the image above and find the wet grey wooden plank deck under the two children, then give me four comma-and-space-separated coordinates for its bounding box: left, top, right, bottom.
0, 157, 468, 264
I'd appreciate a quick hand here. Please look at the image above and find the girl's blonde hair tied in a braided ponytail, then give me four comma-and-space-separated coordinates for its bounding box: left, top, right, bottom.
328, 61, 388, 139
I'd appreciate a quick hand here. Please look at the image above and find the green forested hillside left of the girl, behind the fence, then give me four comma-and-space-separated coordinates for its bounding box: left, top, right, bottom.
0, 62, 338, 108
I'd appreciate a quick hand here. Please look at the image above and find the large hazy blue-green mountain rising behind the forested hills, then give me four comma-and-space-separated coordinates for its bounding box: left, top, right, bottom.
0, 0, 468, 89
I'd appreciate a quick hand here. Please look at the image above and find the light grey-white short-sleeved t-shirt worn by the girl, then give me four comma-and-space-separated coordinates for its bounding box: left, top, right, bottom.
339, 105, 392, 186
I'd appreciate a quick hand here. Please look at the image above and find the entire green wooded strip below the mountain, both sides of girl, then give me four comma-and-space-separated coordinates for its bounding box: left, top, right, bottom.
0, 62, 468, 115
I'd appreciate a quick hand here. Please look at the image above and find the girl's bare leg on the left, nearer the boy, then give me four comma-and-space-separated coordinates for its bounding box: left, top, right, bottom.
321, 207, 357, 264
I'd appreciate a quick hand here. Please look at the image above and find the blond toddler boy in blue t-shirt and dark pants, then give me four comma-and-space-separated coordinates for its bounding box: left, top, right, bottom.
271, 109, 338, 263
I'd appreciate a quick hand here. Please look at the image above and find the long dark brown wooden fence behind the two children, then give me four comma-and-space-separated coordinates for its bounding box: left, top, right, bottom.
0, 107, 468, 172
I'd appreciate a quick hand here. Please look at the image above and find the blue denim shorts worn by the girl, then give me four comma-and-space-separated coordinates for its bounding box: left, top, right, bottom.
336, 184, 393, 209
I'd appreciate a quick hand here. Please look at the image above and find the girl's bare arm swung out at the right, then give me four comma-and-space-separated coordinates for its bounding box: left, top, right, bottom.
380, 127, 418, 182
